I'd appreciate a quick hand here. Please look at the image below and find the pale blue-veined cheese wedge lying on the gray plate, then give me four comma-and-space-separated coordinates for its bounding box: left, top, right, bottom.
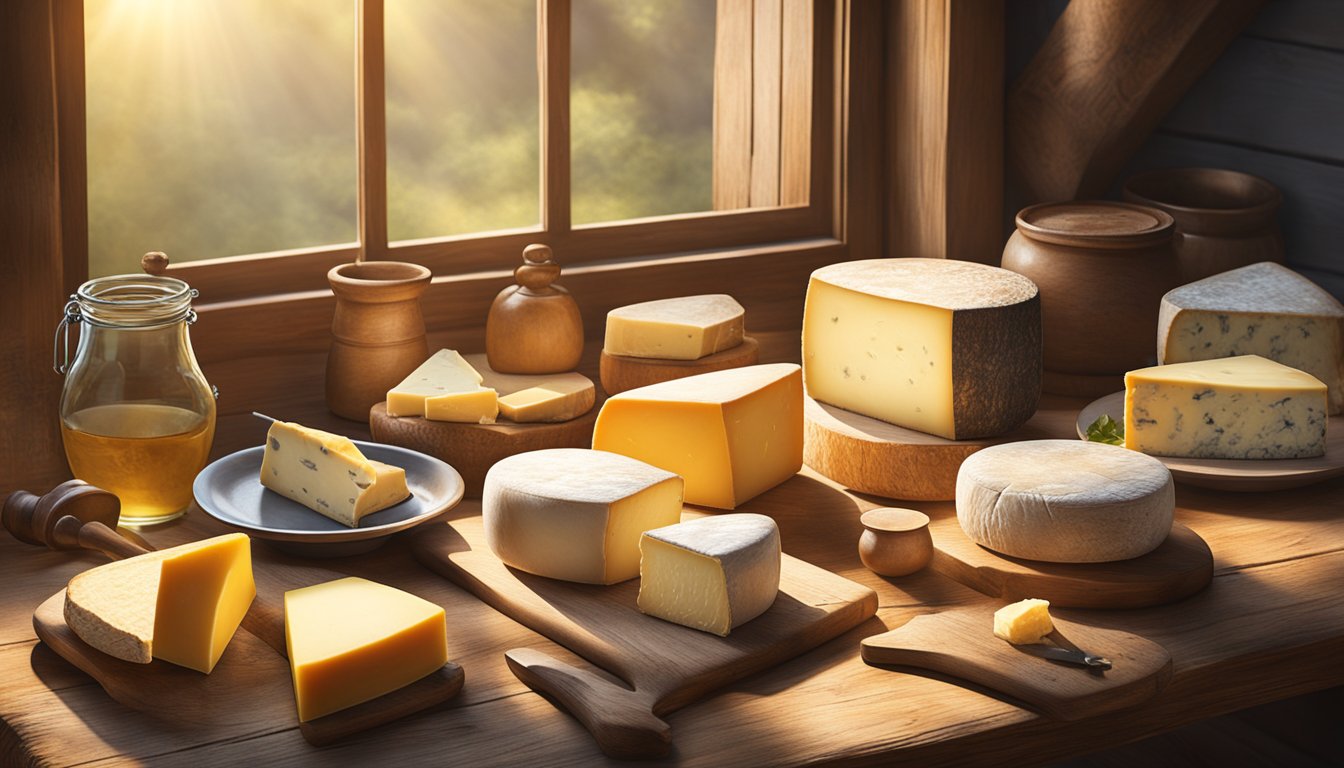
261, 421, 411, 527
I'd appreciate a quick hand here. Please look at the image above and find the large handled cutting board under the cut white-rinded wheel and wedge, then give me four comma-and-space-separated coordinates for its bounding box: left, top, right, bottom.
414, 516, 878, 759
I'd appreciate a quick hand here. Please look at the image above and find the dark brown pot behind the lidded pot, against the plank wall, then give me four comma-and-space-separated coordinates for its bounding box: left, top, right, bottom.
1124, 168, 1284, 284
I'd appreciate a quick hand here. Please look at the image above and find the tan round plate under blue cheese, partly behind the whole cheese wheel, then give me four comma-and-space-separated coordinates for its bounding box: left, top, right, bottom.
1077, 391, 1344, 491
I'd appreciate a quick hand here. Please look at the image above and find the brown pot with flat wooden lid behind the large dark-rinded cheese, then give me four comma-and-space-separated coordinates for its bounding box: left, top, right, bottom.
1003, 200, 1179, 395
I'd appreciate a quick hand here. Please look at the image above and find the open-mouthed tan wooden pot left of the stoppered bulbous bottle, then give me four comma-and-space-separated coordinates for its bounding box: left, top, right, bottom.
327, 261, 431, 421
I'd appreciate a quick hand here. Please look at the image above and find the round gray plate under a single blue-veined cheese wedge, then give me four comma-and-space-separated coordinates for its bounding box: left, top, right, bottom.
192, 440, 465, 557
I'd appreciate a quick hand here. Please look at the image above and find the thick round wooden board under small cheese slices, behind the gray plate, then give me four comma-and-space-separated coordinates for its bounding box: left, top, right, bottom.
368, 402, 602, 499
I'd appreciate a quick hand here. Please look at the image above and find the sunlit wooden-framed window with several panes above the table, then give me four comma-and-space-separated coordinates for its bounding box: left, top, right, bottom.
78, 0, 839, 301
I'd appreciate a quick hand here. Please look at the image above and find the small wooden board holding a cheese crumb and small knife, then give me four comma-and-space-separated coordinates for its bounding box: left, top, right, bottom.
862, 605, 1172, 720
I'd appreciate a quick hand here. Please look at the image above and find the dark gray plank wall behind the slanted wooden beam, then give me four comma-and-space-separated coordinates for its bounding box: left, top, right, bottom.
1005, 0, 1344, 299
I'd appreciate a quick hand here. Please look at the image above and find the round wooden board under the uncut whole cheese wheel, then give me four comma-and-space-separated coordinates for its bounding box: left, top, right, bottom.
929, 515, 1214, 608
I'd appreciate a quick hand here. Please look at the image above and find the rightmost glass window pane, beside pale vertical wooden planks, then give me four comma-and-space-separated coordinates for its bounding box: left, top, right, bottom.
570, 0, 715, 223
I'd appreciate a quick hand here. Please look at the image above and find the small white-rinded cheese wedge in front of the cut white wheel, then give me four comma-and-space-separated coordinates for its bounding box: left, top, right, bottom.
638, 512, 781, 638
